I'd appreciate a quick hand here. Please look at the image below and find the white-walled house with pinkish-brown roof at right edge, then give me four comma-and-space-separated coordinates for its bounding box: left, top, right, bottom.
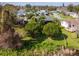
61, 19, 79, 32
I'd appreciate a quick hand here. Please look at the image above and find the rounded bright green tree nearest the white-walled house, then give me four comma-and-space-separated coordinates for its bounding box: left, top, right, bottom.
42, 22, 61, 37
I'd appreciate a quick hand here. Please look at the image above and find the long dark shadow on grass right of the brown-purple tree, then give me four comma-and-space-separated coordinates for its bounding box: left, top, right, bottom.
21, 35, 47, 50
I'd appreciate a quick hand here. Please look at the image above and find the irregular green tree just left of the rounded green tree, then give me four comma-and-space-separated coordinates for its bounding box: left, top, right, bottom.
25, 17, 44, 37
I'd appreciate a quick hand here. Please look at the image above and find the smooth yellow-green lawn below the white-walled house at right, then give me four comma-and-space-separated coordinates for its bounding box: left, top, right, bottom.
63, 29, 79, 48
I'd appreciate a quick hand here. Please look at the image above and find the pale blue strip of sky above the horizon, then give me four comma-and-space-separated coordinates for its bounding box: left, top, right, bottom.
1, 2, 79, 6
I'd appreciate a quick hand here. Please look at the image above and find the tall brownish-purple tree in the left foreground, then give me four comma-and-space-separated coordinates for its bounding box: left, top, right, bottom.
0, 8, 21, 48
